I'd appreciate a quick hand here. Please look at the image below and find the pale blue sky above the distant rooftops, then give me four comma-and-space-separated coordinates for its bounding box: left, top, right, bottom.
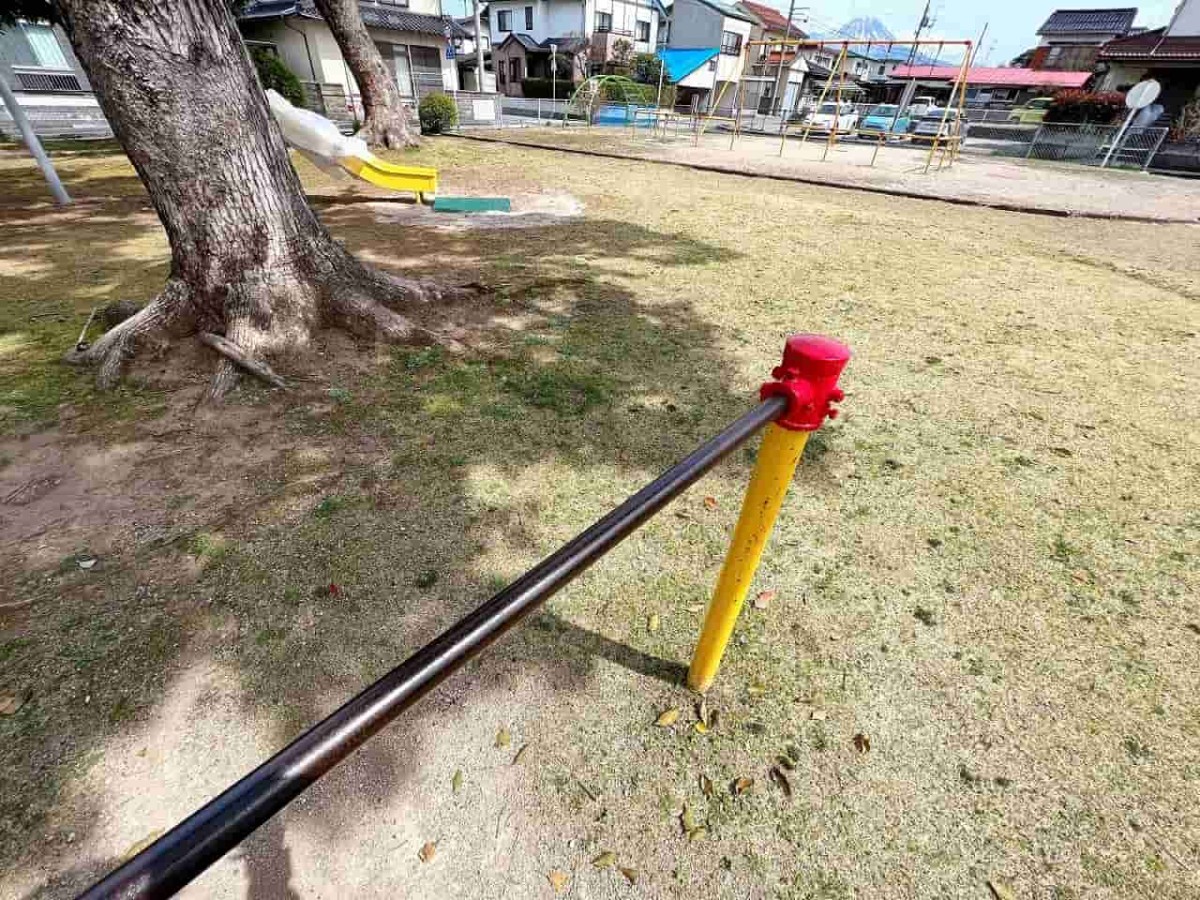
758, 0, 1178, 66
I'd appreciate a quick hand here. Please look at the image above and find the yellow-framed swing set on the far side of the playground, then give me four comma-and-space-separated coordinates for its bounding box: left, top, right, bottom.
695, 38, 974, 173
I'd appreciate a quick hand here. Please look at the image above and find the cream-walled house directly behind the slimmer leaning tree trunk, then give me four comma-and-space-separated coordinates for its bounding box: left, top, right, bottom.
238, 0, 466, 121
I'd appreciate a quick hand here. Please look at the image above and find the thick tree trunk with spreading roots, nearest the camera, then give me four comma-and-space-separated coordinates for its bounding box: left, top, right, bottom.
51, 0, 456, 400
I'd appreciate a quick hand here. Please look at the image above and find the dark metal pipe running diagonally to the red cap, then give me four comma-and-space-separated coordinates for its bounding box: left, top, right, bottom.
80, 397, 788, 900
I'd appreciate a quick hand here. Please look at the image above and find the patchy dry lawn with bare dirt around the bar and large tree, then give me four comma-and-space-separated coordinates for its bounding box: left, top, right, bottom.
0, 139, 1200, 900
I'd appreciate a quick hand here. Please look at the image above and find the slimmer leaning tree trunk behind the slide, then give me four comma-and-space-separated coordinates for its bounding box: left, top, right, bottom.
313, 0, 420, 149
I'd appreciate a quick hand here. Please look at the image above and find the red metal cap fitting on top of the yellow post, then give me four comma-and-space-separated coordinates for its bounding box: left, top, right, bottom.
758, 335, 850, 431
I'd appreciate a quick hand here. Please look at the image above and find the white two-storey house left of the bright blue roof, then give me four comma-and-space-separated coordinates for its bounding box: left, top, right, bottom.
487, 0, 665, 97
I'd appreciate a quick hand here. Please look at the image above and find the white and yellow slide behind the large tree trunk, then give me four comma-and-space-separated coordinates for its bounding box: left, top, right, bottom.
266, 90, 438, 203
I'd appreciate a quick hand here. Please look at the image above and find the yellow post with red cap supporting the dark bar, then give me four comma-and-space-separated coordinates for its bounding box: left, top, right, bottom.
688, 335, 850, 694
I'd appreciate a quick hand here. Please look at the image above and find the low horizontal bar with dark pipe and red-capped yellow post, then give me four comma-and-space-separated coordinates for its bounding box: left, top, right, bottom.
79, 335, 850, 900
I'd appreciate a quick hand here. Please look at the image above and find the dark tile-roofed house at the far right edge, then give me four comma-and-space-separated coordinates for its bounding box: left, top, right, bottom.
1099, 0, 1200, 120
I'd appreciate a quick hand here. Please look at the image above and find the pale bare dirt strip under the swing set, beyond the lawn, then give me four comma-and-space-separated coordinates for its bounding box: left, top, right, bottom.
468, 128, 1200, 222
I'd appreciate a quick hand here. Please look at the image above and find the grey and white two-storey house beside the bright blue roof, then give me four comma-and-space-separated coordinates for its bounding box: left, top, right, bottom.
666, 0, 755, 115
